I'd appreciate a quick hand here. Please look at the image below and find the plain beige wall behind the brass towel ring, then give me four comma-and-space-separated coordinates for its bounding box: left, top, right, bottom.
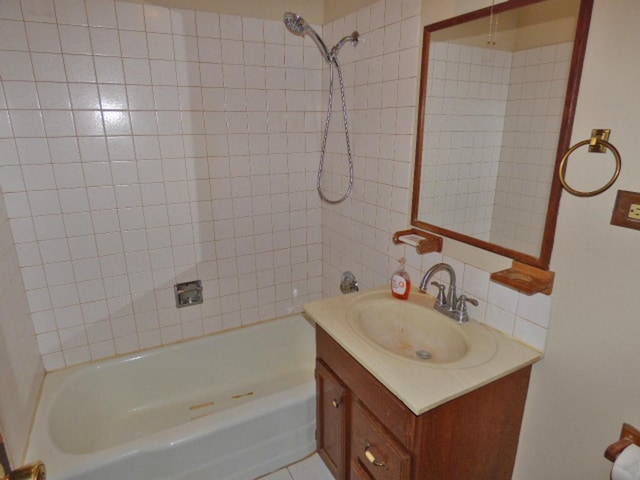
514, 0, 640, 480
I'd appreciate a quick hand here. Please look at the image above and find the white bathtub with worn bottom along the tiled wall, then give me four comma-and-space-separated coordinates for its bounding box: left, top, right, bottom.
26, 315, 316, 480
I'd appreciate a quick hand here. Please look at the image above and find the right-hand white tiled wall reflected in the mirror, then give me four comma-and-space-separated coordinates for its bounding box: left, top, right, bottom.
491, 42, 573, 255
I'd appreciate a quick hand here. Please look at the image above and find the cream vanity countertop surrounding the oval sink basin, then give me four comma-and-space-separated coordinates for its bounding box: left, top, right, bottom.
304, 287, 542, 415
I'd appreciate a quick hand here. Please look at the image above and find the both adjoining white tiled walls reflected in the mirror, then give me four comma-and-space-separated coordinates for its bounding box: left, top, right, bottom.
420, 42, 572, 256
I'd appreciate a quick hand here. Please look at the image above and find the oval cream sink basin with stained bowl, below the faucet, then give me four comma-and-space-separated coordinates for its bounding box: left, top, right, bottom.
347, 291, 497, 368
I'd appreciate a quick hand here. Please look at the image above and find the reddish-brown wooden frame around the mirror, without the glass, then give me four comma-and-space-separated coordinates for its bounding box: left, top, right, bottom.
411, 0, 593, 270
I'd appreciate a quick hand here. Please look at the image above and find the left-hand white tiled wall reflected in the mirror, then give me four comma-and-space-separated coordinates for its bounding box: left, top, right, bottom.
420, 42, 512, 241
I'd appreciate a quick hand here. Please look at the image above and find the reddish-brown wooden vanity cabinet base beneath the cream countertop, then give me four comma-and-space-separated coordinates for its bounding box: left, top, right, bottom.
316, 327, 531, 480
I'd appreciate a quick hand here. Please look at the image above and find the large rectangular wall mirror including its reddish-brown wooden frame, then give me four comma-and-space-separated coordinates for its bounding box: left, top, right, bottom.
411, 0, 593, 270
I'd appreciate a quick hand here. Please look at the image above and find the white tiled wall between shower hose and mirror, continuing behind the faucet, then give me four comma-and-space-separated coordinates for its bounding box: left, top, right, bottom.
322, 0, 551, 350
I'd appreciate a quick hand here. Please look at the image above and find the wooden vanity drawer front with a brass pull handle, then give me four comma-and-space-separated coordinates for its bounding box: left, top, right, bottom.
351, 401, 411, 480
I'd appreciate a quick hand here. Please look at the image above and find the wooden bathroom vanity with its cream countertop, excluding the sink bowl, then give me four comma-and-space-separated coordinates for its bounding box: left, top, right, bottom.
305, 290, 540, 480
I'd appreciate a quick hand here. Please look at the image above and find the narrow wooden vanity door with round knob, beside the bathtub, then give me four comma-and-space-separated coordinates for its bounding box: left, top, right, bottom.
316, 360, 349, 480
